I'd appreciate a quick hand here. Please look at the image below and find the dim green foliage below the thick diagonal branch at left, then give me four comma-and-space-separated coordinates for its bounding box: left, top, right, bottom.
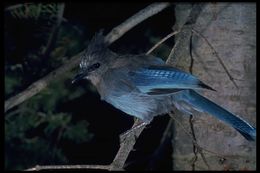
5, 73, 88, 169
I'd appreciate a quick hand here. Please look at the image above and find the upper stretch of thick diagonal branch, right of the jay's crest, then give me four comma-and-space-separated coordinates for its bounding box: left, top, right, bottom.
106, 2, 170, 43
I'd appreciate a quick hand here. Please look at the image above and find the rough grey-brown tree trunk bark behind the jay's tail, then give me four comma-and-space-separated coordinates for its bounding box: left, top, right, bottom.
169, 3, 256, 170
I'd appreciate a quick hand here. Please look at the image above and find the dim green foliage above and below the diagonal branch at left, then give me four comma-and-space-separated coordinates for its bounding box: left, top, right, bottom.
5, 3, 93, 170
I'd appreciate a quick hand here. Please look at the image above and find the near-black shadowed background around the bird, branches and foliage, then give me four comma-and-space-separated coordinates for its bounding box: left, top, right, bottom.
5, 3, 174, 170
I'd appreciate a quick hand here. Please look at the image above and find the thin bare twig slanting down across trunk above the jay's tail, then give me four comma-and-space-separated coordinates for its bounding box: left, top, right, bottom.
192, 29, 238, 88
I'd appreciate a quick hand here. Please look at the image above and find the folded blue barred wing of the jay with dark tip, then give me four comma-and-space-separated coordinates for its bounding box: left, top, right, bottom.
129, 66, 214, 95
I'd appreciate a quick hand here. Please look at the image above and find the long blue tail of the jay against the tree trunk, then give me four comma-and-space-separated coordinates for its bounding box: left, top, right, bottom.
173, 90, 256, 140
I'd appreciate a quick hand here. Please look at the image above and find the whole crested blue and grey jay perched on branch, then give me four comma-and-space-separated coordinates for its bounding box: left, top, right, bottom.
72, 32, 256, 140
